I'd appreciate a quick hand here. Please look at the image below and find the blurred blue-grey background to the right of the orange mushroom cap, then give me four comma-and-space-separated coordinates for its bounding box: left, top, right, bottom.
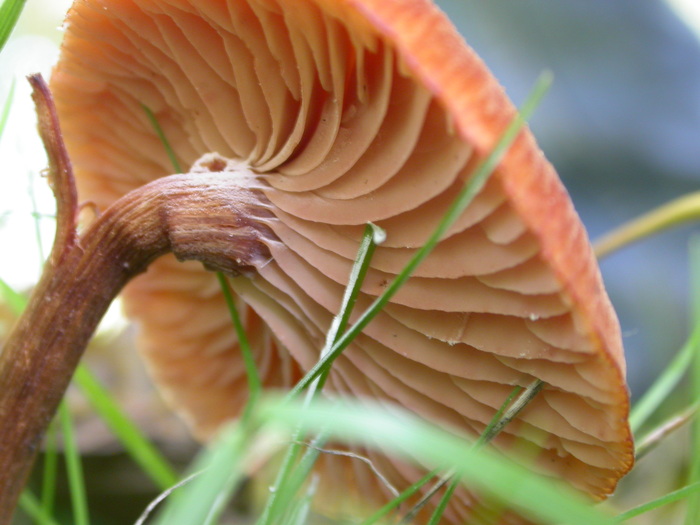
440, 0, 700, 402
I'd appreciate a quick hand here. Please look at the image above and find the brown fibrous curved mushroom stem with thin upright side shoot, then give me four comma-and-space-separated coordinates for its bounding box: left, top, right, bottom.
0, 76, 271, 524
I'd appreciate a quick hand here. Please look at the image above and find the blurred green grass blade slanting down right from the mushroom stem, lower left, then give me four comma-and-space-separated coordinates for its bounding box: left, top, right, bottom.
73, 365, 179, 490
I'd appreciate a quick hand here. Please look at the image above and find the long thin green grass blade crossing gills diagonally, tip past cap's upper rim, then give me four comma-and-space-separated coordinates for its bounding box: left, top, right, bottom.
290, 73, 551, 397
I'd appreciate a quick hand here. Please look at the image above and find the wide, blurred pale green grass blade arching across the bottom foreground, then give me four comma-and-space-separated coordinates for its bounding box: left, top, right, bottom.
256, 399, 612, 525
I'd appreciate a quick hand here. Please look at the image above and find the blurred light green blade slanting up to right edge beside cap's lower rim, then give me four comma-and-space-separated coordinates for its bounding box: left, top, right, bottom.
630, 323, 700, 435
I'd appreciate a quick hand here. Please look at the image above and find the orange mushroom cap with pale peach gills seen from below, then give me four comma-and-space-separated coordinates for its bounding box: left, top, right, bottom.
52, 0, 633, 520
